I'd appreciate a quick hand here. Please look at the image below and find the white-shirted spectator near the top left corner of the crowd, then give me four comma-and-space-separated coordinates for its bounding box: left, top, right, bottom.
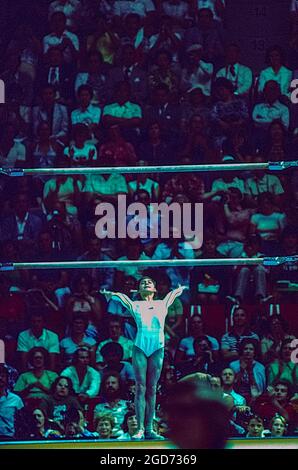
43, 11, 80, 64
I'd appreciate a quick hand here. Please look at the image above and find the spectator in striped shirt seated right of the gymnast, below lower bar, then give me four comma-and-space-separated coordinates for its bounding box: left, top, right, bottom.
221, 307, 259, 361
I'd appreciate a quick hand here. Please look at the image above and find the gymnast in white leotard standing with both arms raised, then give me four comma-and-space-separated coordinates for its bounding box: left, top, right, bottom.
101, 277, 187, 439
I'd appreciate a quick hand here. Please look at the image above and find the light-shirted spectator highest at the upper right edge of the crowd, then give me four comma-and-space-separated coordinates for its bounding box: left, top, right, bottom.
258, 46, 293, 97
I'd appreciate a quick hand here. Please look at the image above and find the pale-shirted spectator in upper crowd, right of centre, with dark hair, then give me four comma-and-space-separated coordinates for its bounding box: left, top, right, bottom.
180, 44, 213, 96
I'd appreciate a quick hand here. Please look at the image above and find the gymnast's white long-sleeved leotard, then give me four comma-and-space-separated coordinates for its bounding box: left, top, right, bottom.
112, 287, 183, 357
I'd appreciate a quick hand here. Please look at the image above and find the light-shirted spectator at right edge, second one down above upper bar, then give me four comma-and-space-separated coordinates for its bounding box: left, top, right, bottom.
252, 80, 290, 130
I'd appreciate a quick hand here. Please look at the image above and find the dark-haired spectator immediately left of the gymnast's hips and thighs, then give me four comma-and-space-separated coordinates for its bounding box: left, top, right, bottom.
99, 341, 135, 385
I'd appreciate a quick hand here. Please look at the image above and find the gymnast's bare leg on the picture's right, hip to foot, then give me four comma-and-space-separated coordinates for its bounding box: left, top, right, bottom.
145, 348, 164, 439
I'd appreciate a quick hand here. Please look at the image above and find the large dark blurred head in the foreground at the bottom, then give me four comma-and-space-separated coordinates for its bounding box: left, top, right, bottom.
166, 381, 229, 449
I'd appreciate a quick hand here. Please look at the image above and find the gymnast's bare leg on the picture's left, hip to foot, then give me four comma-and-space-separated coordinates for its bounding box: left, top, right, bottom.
132, 346, 148, 439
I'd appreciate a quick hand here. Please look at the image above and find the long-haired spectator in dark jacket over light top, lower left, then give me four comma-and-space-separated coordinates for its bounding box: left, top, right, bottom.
40, 375, 81, 430
